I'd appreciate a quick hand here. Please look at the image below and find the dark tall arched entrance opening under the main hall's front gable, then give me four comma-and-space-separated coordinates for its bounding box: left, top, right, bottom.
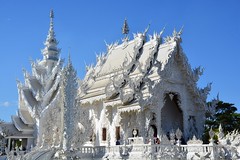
161, 93, 183, 134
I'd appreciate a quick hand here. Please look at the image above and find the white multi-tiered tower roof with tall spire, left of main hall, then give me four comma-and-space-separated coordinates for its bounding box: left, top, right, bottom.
9, 11, 62, 142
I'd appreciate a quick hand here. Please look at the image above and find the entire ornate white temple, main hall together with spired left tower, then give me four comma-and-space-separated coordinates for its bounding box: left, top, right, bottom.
0, 11, 240, 159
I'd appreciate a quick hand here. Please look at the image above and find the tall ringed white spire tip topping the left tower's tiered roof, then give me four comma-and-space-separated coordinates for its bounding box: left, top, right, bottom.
42, 10, 60, 61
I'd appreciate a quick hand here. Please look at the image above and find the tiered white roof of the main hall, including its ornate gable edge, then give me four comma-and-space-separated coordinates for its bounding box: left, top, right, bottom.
80, 25, 210, 107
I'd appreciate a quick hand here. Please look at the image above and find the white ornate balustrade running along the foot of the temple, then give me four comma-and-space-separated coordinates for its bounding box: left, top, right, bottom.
3, 144, 238, 160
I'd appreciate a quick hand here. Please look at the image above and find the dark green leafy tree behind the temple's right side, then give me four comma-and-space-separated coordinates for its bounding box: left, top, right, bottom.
203, 101, 240, 143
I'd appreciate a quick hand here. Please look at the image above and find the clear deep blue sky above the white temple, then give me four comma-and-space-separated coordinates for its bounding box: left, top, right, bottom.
0, 0, 240, 121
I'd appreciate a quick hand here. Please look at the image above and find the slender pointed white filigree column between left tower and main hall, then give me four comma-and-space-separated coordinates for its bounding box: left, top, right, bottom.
61, 56, 78, 151
